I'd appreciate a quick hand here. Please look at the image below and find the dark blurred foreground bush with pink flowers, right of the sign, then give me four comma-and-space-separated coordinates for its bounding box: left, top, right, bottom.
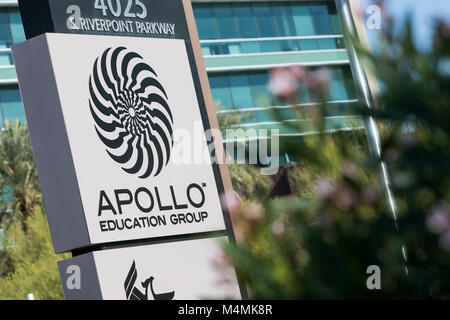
225, 16, 450, 299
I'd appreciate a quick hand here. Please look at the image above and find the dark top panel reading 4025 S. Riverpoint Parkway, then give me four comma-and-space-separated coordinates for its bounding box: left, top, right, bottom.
19, 0, 190, 39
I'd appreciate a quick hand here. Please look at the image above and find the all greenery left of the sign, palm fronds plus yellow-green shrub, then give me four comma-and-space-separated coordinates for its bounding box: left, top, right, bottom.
0, 122, 68, 299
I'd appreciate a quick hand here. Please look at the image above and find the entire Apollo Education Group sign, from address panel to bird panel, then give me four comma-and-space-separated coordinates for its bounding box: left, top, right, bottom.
12, 0, 243, 300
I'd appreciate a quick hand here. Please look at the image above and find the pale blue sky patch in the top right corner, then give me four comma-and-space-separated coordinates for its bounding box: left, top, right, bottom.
360, 0, 450, 50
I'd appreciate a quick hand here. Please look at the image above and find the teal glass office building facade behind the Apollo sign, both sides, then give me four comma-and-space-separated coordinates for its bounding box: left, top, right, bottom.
0, 0, 361, 162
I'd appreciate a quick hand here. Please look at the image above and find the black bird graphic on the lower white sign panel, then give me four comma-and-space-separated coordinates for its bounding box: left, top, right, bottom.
124, 261, 175, 300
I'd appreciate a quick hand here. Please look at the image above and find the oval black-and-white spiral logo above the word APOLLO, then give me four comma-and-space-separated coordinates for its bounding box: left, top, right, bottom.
89, 47, 173, 179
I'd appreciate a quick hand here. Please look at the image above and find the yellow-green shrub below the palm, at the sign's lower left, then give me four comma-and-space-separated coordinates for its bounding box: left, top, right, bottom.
0, 207, 70, 300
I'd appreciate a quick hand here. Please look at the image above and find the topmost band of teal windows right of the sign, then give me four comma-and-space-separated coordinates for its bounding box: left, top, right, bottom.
194, 2, 344, 56
